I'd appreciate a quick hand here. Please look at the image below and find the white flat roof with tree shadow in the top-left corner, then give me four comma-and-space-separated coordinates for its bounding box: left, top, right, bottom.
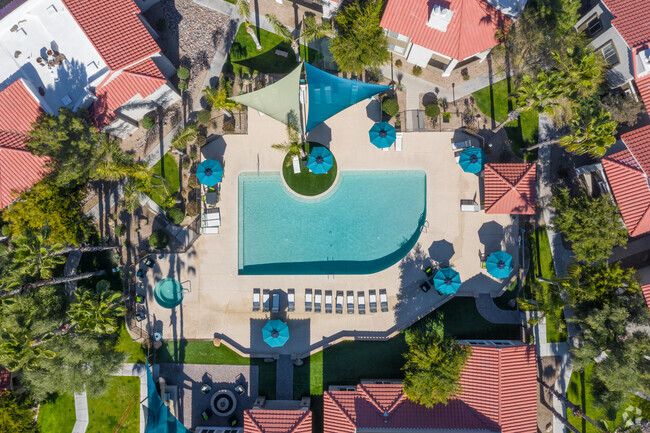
0, 0, 108, 111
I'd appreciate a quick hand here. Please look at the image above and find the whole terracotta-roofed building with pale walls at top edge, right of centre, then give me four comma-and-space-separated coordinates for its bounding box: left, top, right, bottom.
381, 0, 526, 77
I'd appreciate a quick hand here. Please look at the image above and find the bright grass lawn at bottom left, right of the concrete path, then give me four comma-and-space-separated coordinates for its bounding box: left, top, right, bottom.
87, 376, 140, 433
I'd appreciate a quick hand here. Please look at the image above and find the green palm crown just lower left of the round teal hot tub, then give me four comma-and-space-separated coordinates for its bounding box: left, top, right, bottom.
68, 289, 126, 334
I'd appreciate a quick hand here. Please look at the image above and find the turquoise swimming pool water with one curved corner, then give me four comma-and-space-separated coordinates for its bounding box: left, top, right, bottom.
239, 171, 426, 275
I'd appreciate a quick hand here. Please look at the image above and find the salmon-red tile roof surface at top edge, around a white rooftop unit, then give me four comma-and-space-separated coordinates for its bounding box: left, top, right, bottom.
381, 0, 511, 60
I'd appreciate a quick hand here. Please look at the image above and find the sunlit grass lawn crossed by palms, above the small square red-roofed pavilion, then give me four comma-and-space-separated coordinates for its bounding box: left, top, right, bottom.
472, 79, 539, 156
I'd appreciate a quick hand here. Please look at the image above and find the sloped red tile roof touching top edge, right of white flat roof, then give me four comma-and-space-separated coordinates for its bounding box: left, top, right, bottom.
63, 0, 160, 71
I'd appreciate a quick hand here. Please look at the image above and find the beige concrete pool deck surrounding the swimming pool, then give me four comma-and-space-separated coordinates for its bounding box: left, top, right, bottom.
139, 101, 519, 357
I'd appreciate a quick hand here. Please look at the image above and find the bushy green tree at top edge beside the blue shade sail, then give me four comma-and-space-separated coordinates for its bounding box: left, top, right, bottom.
330, 0, 390, 74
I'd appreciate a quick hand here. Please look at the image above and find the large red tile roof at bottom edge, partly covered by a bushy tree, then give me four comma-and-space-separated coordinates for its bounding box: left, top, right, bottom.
324, 345, 537, 433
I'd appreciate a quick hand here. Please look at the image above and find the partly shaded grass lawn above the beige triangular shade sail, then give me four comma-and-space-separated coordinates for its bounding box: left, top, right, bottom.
224, 25, 321, 75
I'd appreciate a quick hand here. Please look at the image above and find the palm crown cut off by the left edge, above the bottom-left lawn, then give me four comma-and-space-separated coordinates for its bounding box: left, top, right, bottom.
0, 330, 56, 372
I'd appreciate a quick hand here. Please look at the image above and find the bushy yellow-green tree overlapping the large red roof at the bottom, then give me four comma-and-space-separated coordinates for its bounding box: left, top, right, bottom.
402, 316, 471, 408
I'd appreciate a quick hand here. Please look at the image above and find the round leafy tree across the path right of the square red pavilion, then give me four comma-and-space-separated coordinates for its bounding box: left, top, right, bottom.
551, 188, 627, 263
